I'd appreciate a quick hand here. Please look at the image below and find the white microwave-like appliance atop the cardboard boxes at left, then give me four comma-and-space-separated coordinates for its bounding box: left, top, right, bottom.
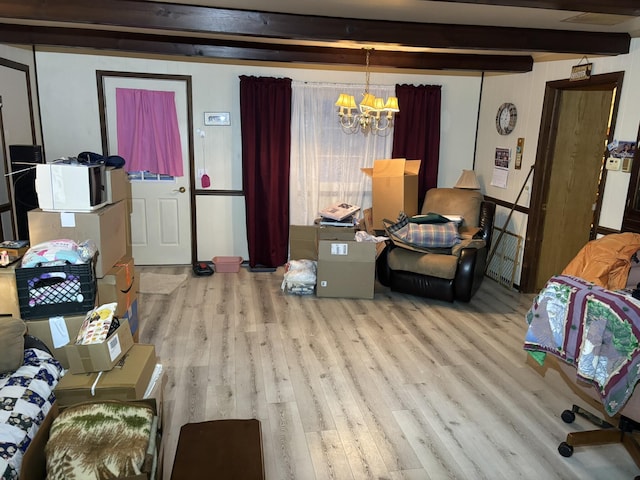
35, 162, 107, 212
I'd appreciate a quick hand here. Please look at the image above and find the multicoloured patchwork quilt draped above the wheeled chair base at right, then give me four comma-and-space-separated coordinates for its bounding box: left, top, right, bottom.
524, 275, 640, 416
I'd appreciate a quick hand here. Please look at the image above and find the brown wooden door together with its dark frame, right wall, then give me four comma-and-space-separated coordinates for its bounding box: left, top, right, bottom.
520, 72, 624, 293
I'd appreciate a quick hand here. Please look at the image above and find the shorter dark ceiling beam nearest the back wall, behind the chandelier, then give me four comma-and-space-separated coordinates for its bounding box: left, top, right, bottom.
0, 24, 533, 72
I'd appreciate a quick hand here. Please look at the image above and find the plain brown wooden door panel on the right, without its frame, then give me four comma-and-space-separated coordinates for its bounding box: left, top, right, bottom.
536, 90, 613, 290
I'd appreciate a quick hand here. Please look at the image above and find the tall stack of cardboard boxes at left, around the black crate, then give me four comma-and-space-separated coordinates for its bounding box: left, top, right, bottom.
0, 164, 165, 479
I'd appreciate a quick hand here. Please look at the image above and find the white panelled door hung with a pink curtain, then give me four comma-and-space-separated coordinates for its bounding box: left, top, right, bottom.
104, 76, 191, 265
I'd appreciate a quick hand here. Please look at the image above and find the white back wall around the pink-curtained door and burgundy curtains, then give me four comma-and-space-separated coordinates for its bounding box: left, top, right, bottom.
30, 51, 481, 260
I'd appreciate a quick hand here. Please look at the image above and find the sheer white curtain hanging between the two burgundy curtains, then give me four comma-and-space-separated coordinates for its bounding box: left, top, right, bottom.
289, 81, 395, 225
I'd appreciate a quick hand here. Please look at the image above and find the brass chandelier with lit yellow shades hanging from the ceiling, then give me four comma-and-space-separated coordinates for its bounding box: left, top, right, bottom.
335, 48, 400, 134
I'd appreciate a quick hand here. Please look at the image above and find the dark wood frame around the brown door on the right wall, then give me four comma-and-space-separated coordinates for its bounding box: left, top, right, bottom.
520, 72, 624, 293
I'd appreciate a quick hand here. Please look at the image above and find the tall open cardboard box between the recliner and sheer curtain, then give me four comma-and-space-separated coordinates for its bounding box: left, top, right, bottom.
361, 158, 421, 230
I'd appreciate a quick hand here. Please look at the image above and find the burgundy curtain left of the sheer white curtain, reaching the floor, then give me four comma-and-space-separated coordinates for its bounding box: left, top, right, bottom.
240, 75, 291, 268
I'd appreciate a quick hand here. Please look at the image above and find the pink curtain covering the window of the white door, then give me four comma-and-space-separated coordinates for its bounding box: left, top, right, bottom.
116, 88, 184, 177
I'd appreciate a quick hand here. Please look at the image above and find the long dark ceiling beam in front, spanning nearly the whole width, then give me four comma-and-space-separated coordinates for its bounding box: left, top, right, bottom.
0, 0, 631, 55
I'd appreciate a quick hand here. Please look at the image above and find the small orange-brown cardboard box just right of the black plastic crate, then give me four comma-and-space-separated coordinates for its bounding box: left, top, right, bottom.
98, 255, 140, 318
